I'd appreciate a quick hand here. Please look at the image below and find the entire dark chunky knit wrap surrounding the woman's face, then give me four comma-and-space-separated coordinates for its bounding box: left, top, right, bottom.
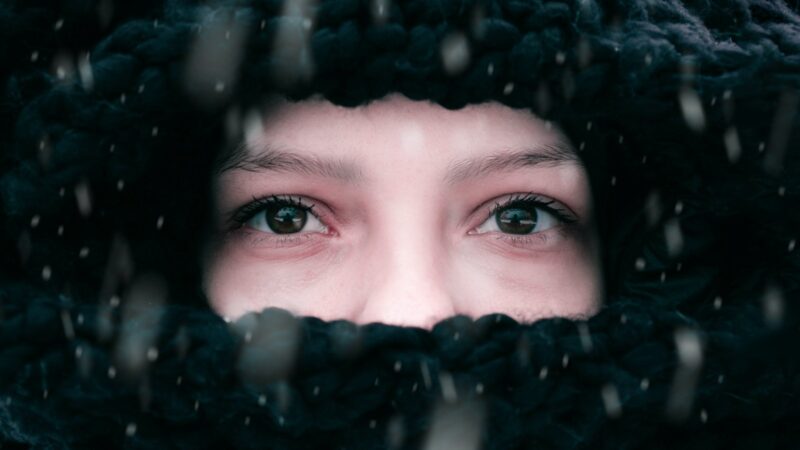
0, 0, 800, 449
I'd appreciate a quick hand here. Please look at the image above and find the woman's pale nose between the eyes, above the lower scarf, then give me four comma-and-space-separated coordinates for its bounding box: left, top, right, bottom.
356, 204, 456, 328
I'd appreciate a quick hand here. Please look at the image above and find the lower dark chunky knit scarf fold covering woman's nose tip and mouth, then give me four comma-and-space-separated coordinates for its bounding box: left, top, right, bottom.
0, 284, 800, 449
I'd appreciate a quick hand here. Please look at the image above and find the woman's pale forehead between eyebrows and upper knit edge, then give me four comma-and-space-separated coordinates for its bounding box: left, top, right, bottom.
253, 95, 567, 160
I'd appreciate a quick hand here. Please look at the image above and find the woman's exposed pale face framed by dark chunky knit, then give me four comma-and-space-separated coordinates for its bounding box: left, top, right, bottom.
205, 96, 599, 328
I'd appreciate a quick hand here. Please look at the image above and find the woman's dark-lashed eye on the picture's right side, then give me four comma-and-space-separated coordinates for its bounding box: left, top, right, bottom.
471, 193, 577, 245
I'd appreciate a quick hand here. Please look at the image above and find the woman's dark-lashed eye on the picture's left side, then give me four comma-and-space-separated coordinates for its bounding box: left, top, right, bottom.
231, 195, 329, 244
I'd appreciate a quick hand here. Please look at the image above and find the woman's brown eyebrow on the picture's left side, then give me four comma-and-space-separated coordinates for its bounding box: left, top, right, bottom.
216, 143, 364, 182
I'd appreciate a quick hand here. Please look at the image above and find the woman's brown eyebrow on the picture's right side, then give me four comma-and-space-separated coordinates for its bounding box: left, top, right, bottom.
445, 142, 583, 184
